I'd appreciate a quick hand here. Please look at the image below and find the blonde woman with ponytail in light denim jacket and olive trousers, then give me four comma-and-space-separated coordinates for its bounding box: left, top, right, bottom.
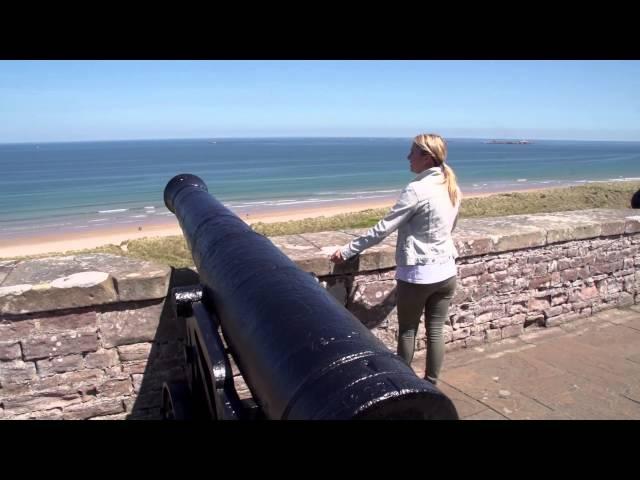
331, 134, 462, 385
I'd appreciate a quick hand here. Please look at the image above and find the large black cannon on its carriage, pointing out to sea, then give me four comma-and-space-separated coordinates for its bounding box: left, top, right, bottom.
163, 174, 458, 420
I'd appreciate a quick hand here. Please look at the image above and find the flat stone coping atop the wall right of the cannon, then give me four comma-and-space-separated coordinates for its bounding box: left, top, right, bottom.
271, 208, 640, 276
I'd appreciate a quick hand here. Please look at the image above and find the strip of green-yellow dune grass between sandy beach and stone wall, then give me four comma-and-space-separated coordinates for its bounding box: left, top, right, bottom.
13, 182, 640, 268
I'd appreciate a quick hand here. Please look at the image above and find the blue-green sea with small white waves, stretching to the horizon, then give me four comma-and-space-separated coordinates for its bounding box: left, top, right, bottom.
0, 138, 640, 241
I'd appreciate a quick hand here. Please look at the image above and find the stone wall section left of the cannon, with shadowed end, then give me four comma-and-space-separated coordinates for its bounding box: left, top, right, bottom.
0, 255, 183, 419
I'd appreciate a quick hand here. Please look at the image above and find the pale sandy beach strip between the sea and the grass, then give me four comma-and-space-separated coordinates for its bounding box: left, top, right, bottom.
0, 188, 560, 258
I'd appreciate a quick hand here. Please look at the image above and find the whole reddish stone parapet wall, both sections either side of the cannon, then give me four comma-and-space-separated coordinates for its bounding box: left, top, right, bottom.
0, 210, 640, 419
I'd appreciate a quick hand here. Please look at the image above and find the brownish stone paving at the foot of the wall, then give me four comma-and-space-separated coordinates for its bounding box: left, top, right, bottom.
413, 305, 640, 420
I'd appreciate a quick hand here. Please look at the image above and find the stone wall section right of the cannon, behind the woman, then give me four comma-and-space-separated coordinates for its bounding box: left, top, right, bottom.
273, 209, 640, 351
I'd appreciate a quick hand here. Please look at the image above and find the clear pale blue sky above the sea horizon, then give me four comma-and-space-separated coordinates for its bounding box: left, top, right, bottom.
0, 60, 640, 143
